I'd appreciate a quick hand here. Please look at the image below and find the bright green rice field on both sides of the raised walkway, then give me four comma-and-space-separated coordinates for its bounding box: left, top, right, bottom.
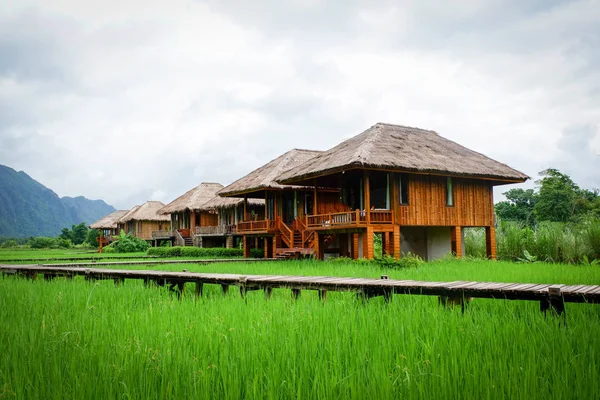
0, 255, 600, 399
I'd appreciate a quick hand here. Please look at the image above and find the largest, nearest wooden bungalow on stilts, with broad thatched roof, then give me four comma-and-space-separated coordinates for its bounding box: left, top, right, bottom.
277, 123, 529, 259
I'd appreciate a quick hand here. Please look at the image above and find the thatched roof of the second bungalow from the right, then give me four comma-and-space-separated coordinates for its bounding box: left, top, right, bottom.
218, 149, 322, 196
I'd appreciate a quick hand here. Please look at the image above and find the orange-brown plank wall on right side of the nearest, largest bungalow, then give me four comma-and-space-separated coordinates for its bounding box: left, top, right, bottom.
391, 174, 494, 226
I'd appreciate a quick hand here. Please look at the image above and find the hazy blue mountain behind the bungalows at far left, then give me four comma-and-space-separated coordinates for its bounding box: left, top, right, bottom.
0, 165, 115, 237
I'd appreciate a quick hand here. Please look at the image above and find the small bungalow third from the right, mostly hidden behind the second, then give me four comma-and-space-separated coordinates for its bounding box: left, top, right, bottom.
195, 196, 265, 248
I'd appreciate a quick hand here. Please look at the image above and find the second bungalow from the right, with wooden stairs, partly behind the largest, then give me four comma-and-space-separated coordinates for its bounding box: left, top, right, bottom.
218, 149, 345, 258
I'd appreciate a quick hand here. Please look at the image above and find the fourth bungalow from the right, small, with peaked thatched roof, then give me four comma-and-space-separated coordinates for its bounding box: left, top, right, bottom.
154, 182, 223, 246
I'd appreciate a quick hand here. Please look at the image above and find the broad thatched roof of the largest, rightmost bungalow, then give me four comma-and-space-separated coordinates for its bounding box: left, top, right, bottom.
277, 123, 529, 184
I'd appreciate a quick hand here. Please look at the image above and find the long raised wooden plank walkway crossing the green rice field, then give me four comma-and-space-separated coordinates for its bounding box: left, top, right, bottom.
0, 261, 600, 314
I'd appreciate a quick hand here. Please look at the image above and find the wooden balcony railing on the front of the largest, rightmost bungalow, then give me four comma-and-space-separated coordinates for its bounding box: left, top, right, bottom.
306, 210, 394, 228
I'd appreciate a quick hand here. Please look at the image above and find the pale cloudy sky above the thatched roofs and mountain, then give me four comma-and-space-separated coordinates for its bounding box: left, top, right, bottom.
0, 0, 600, 209
